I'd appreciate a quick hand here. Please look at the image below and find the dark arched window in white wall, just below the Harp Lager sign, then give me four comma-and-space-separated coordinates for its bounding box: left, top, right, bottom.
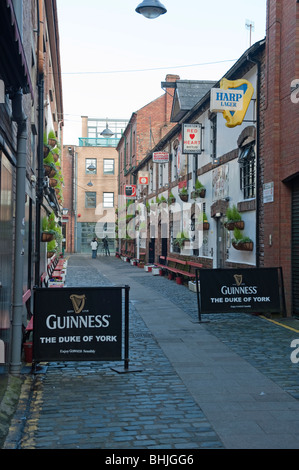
238, 143, 255, 199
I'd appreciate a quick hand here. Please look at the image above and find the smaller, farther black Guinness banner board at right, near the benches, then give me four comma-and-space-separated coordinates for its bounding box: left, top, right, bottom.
199, 268, 284, 313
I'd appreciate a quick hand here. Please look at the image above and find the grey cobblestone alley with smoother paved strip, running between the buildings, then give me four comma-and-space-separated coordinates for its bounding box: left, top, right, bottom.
4, 255, 299, 449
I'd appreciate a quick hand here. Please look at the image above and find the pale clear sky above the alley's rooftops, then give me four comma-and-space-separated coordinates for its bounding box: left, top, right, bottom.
57, 0, 267, 145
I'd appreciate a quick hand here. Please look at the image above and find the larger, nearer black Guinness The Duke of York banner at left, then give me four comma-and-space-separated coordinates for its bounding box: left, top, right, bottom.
33, 287, 122, 362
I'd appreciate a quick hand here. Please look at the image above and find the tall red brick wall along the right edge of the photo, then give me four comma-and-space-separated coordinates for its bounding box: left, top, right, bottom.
259, 0, 299, 315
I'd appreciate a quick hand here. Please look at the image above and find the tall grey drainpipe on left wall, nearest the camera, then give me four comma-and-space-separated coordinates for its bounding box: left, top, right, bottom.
10, 90, 28, 375
